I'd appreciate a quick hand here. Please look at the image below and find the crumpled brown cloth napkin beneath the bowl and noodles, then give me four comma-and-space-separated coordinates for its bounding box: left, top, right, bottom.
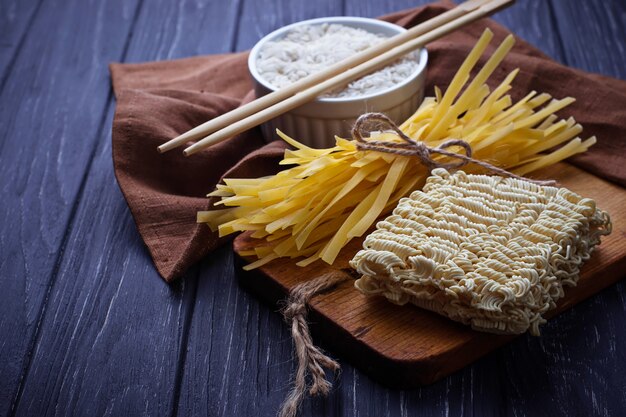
111, 2, 626, 281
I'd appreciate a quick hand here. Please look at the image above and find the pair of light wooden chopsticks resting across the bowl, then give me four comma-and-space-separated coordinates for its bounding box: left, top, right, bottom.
157, 0, 515, 156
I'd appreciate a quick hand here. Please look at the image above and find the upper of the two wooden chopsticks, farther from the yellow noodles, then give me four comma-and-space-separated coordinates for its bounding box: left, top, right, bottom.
157, 0, 492, 152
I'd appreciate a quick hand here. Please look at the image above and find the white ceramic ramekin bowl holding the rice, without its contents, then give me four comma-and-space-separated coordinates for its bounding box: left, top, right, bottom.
248, 17, 428, 148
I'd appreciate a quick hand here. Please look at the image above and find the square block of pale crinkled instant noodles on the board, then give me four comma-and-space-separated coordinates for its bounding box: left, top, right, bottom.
351, 168, 611, 335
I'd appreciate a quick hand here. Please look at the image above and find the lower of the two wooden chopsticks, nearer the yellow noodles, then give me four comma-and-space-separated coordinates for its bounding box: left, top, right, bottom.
168, 0, 514, 156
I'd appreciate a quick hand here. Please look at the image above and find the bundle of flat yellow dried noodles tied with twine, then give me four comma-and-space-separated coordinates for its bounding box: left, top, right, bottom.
198, 30, 595, 269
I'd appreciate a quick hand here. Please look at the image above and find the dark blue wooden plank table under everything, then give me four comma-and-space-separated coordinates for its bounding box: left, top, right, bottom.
0, 0, 626, 416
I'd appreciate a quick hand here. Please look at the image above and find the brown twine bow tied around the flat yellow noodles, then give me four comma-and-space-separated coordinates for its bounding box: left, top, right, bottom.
352, 113, 556, 185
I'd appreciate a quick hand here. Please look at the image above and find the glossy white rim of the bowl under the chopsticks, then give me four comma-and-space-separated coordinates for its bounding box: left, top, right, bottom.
248, 16, 428, 103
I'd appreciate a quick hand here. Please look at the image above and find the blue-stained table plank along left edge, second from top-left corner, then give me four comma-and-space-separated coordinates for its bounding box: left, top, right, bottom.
0, 0, 141, 415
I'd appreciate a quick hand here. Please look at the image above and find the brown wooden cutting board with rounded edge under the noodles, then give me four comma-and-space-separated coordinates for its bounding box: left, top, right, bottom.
234, 163, 626, 388
